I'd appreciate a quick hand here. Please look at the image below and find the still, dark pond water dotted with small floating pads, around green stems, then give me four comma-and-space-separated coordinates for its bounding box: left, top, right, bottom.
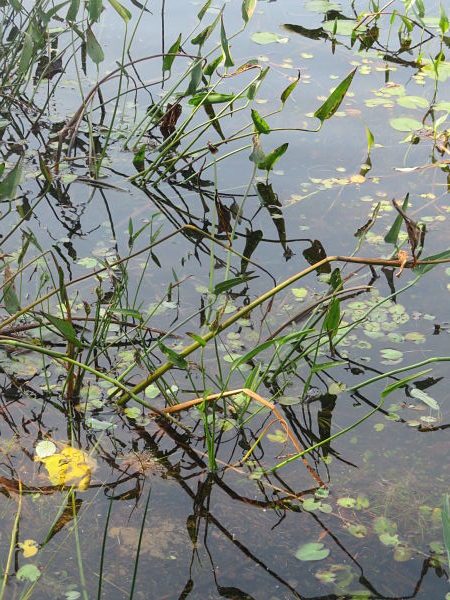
0, 0, 450, 600
